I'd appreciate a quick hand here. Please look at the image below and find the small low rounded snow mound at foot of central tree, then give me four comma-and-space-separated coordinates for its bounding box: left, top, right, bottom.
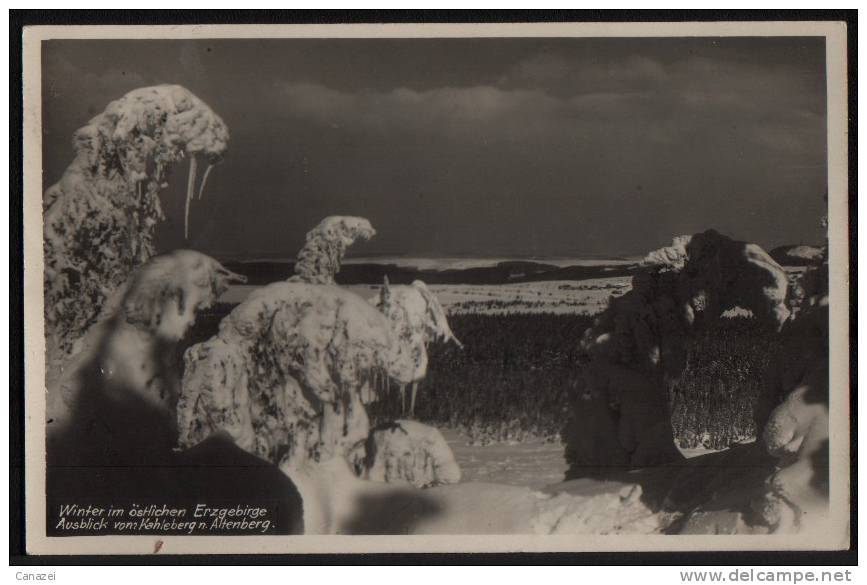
356, 420, 461, 487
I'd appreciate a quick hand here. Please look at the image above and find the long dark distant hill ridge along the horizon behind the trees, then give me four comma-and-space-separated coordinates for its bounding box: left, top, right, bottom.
225, 260, 634, 285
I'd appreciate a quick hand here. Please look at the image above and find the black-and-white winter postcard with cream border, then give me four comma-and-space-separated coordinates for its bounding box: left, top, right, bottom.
24, 23, 850, 554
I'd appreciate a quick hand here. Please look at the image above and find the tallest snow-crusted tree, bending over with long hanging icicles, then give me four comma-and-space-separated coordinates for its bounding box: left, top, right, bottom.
43, 85, 229, 366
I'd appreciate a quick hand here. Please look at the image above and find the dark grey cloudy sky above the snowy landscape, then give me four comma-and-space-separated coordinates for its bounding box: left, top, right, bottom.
43, 38, 826, 259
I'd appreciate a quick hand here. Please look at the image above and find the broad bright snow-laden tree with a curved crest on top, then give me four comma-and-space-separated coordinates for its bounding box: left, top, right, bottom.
178, 216, 394, 470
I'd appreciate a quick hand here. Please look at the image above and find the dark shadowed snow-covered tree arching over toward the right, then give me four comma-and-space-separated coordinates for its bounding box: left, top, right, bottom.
567, 230, 789, 474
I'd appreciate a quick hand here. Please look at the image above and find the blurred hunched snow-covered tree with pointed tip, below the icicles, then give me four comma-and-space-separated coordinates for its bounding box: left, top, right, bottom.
49, 250, 244, 454
